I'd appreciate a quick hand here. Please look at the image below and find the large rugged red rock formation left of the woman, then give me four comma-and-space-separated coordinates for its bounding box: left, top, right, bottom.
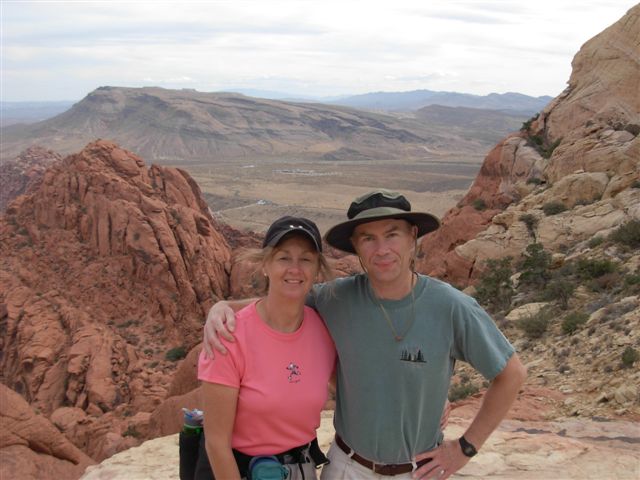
0, 141, 230, 459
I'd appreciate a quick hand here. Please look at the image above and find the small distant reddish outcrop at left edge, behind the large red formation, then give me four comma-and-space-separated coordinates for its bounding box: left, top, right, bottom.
0, 146, 62, 211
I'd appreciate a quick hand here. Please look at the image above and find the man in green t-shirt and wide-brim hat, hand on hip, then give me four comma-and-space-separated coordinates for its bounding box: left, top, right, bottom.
205, 190, 526, 480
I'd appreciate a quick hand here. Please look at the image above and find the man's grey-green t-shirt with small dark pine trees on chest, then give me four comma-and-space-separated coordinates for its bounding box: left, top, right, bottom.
308, 275, 514, 463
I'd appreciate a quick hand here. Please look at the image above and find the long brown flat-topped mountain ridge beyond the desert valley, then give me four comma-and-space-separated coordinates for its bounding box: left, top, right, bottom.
0, 87, 527, 164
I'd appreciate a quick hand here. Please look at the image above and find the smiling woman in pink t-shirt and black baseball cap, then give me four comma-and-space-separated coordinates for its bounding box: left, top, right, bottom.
198, 217, 336, 480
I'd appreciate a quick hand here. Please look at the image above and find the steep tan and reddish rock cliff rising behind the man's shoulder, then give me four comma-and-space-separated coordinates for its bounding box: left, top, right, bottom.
420, 6, 640, 286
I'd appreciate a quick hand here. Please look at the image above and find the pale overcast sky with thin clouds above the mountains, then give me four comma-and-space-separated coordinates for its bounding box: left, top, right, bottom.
0, 0, 636, 101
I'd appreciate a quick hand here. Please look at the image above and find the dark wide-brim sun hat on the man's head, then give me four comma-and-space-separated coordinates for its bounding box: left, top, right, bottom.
324, 189, 440, 253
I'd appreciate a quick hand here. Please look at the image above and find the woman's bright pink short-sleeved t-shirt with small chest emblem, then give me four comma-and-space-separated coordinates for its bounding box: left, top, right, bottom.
198, 303, 336, 455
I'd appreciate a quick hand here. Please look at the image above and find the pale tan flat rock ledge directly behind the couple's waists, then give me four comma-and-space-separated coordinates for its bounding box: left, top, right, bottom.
81, 411, 640, 480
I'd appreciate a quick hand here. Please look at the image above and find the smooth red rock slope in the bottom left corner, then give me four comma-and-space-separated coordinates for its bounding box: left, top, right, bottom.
0, 384, 95, 480
